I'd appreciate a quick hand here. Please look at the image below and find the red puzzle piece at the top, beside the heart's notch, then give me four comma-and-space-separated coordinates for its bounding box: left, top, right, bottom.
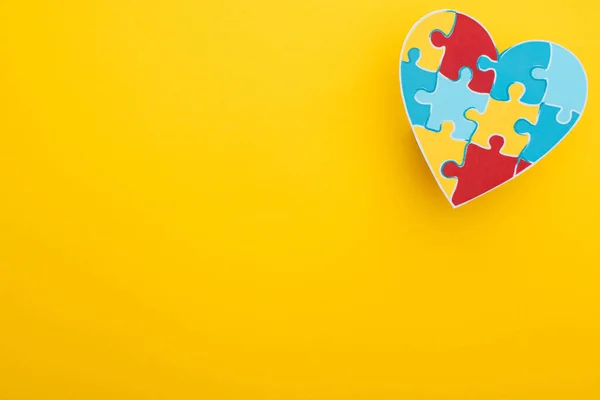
431, 13, 498, 93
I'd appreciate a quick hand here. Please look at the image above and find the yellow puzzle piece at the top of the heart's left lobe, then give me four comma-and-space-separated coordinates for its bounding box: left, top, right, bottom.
402, 11, 456, 72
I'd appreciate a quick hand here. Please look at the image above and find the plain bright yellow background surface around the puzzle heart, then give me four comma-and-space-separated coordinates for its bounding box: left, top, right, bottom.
0, 0, 600, 400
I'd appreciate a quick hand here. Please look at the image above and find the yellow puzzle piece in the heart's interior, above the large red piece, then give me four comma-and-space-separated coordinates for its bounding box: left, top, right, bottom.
465, 83, 539, 157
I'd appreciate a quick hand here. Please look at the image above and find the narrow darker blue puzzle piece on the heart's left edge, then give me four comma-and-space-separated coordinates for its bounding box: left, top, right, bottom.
400, 48, 437, 126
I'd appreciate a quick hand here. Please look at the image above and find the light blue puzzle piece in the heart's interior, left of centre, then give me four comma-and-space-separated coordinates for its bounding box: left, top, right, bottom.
415, 67, 490, 141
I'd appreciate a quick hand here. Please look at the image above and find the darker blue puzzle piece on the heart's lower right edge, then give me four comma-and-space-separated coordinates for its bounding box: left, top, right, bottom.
515, 103, 580, 163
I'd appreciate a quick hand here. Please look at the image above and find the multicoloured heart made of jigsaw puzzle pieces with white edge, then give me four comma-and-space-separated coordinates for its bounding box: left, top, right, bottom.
400, 10, 588, 208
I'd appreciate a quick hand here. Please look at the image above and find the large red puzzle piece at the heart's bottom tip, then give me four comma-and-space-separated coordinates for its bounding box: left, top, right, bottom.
442, 135, 518, 206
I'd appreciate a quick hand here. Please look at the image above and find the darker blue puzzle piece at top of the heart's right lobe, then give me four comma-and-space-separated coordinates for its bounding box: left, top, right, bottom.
477, 41, 550, 105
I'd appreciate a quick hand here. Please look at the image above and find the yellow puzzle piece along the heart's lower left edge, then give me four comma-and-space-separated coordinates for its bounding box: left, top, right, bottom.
413, 121, 467, 198
